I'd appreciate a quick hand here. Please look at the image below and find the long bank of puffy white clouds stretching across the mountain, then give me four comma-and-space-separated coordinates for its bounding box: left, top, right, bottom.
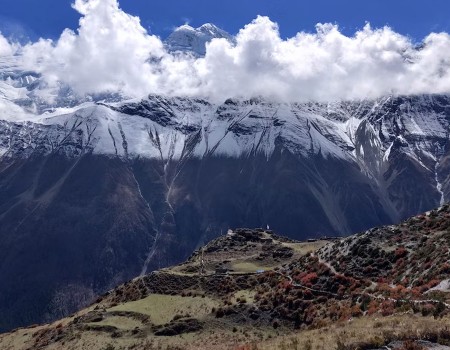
0, 0, 450, 101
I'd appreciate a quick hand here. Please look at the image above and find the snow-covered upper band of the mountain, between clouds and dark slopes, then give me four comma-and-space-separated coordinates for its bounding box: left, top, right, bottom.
0, 91, 450, 167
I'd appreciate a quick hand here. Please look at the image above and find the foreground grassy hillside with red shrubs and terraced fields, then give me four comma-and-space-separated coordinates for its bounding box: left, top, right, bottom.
0, 205, 450, 350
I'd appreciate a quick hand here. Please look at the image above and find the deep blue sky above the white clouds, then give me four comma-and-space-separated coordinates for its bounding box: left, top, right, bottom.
0, 0, 450, 41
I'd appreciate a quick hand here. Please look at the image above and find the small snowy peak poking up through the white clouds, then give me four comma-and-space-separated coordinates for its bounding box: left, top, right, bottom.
165, 23, 234, 56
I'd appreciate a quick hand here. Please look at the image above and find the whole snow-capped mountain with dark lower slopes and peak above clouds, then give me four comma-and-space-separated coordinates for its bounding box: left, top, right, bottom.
0, 26, 450, 329
